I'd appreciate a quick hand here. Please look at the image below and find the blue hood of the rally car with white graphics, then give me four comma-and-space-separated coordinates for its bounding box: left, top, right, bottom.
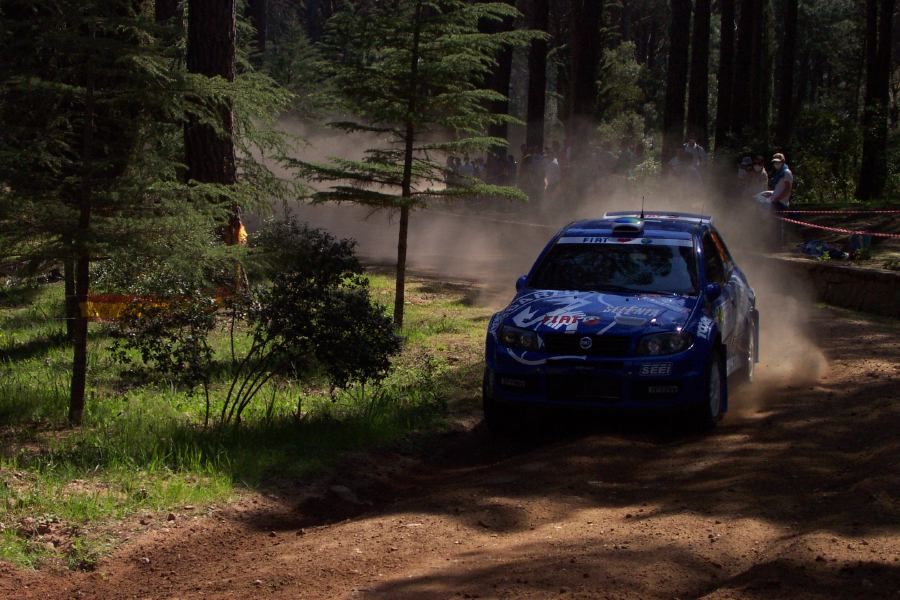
498, 290, 697, 335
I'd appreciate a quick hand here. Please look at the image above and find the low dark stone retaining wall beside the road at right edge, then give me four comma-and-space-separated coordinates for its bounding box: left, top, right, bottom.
774, 256, 900, 317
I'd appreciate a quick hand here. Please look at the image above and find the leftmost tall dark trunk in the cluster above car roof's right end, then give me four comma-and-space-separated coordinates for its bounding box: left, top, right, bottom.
662, 0, 691, 170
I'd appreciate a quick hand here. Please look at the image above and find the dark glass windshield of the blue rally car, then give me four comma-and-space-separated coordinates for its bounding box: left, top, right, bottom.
529, 240, 698, 295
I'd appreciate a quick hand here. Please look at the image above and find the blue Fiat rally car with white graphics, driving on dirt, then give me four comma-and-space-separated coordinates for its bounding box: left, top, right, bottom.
484, 212, 759, 431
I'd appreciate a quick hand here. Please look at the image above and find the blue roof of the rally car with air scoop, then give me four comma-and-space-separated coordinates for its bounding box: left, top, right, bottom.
560, 211, 712, 239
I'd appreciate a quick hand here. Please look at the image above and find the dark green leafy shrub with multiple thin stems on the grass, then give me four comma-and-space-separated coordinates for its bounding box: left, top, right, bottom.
110, 220, 400, 425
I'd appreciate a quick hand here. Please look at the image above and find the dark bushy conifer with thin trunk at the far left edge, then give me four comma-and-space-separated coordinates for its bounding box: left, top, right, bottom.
0, 0, 286, 424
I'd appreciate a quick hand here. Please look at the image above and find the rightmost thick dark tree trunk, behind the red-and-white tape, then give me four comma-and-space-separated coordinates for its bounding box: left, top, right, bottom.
856, 0, 895, 200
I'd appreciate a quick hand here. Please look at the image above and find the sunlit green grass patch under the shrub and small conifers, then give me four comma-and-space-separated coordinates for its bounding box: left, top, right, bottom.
0, 274, 491, 568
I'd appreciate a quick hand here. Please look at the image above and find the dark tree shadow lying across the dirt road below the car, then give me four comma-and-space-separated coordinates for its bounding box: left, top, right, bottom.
234, 304, 900, 534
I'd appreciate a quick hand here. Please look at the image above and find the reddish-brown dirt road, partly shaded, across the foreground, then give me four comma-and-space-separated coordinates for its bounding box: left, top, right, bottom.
0, 290, 900, 599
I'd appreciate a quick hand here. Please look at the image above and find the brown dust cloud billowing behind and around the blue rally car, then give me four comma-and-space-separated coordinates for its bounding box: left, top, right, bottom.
268, 119, 827, 406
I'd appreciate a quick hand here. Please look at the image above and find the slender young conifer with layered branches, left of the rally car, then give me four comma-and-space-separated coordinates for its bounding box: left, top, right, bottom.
296, 0, 534, 327
